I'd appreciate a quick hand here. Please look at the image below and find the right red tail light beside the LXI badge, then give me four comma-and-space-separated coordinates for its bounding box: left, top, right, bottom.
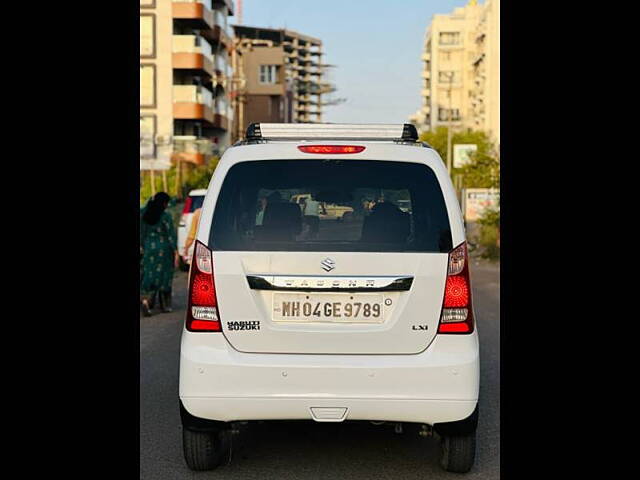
438, 242, 473, 333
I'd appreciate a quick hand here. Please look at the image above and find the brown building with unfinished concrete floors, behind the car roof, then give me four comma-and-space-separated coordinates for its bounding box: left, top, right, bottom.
233, 25, 335, 138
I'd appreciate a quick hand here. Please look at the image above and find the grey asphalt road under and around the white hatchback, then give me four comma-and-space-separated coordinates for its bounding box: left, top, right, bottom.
140, 263, 500, 480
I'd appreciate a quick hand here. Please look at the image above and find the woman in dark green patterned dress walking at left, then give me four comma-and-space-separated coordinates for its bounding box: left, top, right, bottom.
140, 192, 179, 317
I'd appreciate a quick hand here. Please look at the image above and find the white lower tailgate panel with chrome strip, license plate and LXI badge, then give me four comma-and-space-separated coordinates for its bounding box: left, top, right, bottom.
213, 252, 448, 354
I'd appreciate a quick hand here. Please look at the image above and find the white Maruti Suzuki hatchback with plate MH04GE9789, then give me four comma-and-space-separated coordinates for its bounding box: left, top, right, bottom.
179, 123, 480, 472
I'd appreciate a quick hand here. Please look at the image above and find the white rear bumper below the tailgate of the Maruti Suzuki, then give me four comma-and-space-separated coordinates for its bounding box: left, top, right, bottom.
180, 331, 479, 425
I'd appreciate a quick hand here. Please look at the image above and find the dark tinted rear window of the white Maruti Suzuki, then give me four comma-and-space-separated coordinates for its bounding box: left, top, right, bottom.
209, 160, 452, 252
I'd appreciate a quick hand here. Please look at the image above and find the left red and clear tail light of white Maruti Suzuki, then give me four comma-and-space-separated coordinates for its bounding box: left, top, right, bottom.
186, 241, 222, 332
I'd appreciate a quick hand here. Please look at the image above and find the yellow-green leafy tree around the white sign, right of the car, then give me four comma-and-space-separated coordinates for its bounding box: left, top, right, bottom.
420, 126, 500, 188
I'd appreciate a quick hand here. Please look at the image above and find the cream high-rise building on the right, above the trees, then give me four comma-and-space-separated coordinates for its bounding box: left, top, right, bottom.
409, 0, 500, 147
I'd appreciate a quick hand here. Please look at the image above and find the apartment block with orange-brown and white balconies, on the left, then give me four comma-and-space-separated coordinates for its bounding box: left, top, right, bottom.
140, 0, 234, 178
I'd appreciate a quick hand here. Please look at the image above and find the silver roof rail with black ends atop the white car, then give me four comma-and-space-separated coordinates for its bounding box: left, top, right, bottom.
246, 123, 418, 143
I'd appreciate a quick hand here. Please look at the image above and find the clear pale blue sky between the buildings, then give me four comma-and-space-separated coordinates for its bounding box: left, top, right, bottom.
238, 0, 468, 123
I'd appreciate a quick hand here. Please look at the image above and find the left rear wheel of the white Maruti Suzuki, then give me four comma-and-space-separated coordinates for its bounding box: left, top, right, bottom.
182, 428, 231, 471
